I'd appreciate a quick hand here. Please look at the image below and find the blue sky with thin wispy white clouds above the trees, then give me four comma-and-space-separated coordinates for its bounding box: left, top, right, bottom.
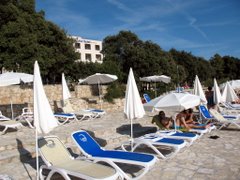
36, 0, 240, 60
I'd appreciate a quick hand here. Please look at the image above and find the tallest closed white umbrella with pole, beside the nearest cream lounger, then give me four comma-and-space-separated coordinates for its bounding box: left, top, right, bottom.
33, 61, 58, 177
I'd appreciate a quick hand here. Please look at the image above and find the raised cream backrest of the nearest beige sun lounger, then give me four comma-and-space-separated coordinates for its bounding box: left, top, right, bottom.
38, 136, 72, 165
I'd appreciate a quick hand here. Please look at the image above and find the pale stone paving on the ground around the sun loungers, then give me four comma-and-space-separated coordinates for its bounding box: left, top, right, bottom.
0, 113, 240, 180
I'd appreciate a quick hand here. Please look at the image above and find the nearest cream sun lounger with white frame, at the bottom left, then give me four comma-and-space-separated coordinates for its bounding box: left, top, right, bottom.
38, 136, 119, 180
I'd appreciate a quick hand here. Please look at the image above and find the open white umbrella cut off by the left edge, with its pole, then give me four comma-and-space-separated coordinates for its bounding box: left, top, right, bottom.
0, 72, 33, 119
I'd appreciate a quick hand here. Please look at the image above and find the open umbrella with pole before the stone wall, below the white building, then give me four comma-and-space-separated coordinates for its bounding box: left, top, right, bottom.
81, 73, 118, 109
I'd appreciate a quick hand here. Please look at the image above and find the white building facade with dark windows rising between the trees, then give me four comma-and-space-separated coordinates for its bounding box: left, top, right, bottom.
71, 36, 103, 63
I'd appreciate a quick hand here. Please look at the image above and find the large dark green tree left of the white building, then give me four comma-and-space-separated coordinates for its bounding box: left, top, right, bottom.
0, 0, 78, 83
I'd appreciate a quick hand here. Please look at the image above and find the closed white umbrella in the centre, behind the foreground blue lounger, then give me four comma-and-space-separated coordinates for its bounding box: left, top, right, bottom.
124, 68, 145, 150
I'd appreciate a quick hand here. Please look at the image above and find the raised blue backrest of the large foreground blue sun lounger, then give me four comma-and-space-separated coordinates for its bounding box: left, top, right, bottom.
72, 131, 102, 155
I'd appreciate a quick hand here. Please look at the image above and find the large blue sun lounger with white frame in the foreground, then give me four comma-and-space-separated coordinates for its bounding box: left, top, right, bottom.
72, 130, 157, 179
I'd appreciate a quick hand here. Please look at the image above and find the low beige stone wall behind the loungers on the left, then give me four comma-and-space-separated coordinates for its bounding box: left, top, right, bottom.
0, 84, 124, 117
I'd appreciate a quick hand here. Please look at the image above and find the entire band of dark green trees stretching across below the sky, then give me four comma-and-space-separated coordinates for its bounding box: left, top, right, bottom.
0, 0, 240, 93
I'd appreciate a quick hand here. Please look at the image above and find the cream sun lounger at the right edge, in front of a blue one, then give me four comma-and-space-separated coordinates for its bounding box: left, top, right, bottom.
210, 109, 240, 129
